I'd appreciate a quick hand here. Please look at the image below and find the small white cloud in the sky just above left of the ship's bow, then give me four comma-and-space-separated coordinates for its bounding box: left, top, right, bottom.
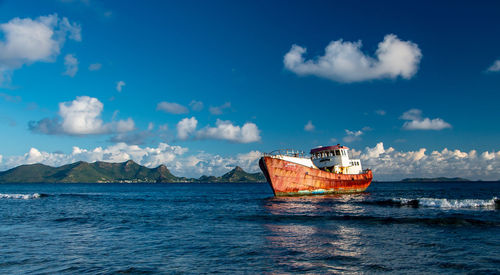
196, 119, 260, 143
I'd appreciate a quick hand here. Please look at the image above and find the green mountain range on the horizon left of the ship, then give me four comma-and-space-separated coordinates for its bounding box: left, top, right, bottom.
0, 160, 266, 183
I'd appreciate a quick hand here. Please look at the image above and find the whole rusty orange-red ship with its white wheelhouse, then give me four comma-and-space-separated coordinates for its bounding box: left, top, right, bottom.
259, 144, 373, 196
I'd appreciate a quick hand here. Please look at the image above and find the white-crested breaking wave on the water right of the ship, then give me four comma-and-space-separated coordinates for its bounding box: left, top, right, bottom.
362, 197, 500, 209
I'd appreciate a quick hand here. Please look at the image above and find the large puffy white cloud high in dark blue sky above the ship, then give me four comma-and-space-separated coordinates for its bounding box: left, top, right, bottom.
283, 34, 422, 82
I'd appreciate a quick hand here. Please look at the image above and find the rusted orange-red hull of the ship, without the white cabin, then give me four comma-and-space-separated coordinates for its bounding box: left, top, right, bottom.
259, 156, 373, 196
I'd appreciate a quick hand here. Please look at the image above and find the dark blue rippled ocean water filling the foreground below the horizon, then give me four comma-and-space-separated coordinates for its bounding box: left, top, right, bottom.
0, 182, 500, 274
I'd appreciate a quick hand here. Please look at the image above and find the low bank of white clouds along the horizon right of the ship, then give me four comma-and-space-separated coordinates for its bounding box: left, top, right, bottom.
361, 142, 500, 180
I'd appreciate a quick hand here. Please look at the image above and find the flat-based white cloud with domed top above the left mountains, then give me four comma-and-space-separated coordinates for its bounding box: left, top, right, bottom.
29, 96, 135, 135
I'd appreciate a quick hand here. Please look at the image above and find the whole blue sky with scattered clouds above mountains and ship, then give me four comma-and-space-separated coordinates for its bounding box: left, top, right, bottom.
0, 0, 500, 179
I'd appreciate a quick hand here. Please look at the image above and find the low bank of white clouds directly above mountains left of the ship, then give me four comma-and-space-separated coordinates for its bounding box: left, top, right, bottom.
0, 143, 261, 177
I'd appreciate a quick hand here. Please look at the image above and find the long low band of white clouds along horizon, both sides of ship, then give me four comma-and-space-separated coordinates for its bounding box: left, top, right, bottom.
5, 142, 500, 180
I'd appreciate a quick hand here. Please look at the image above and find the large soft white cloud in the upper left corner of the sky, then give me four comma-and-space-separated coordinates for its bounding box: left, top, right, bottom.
0, 14, 82, 83
